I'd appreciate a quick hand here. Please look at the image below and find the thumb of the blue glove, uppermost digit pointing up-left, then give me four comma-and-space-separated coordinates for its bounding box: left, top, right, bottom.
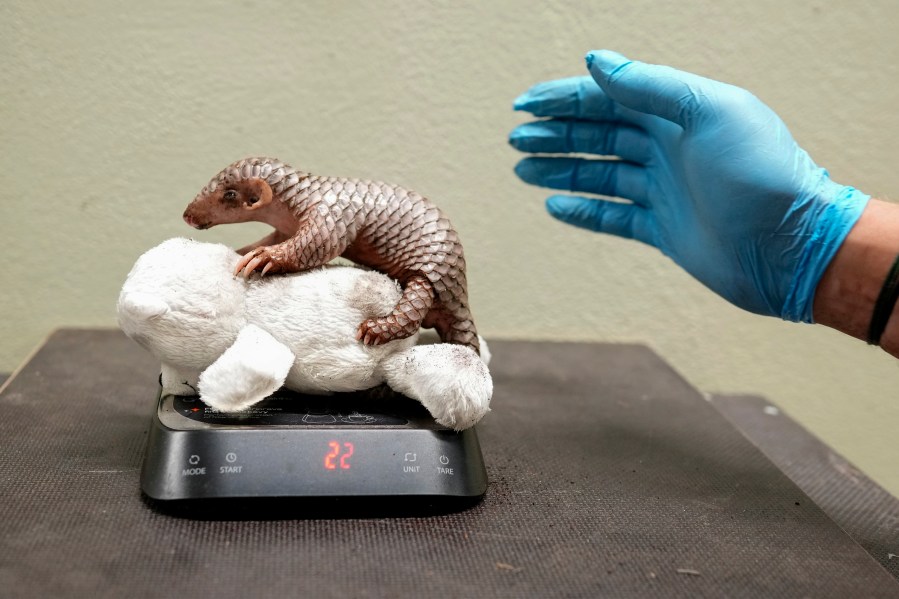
586, 50, 725, 129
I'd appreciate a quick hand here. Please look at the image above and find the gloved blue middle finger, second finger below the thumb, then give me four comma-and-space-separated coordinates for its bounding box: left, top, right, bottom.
509, 120, 652, 164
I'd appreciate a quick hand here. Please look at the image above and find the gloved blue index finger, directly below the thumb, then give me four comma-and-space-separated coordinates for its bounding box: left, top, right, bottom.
514, 77, 646, 123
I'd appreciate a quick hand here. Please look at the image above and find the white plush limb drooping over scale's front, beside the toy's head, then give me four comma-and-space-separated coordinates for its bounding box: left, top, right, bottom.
199, 325, 294, 412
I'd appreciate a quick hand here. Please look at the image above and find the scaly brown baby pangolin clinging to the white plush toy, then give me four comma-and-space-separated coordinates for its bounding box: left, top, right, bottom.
184, 158, 480, 352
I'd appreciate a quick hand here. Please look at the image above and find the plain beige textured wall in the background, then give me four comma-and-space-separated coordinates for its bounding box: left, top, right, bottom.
0, 0, 899, 494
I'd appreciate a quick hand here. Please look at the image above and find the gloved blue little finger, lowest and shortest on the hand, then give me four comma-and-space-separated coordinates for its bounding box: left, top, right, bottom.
546, 196, 656, 246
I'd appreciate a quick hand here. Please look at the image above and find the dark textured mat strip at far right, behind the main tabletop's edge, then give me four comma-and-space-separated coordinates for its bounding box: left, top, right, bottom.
712, 395, 899, 579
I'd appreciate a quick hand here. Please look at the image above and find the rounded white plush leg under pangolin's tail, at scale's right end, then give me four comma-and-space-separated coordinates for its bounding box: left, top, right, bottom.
381, 343, 493, 430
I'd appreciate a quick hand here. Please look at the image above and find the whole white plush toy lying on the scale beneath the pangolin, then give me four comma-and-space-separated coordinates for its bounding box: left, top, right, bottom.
118, 239, 493, 430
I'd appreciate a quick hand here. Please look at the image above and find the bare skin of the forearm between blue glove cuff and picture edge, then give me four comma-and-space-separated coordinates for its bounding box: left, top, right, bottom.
814, 199, 899, 358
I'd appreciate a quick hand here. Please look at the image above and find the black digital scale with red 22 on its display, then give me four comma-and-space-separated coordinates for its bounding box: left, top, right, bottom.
141, 390, 487, 516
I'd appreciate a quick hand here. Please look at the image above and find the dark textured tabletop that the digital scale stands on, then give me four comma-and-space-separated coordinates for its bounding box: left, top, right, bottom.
0, 330, 899, 597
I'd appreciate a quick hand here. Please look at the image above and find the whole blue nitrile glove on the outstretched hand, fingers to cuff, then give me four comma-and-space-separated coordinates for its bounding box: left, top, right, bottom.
509, 50, 868, 322
